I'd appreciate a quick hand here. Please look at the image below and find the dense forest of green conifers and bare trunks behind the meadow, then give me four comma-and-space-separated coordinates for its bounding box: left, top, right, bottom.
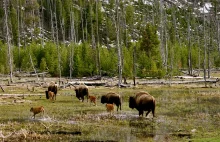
0, 0, 220, 81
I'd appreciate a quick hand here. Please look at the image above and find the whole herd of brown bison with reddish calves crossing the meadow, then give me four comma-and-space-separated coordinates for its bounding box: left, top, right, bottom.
30, 83, 155, 118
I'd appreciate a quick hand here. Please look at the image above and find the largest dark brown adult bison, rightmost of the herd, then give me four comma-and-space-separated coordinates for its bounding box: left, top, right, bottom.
129, 92, 156, 117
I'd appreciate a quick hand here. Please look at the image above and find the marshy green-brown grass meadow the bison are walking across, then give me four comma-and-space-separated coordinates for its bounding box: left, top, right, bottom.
0, 81, 220, 142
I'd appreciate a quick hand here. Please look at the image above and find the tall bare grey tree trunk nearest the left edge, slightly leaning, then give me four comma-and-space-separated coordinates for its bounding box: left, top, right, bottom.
3, 0, 13, 83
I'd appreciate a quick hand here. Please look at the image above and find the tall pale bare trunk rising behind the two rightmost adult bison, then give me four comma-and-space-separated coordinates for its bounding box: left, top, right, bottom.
116, 0, 122, 87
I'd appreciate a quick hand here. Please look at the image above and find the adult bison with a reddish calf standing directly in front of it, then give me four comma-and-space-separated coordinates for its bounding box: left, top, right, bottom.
101, 92, 121, 111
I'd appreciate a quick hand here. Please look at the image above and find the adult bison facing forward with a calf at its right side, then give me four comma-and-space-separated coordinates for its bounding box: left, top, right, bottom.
74, 85, 89, 102
